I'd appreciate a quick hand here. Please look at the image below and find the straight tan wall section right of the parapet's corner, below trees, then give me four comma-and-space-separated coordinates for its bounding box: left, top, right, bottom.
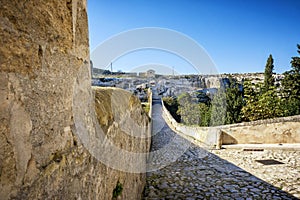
220, 115, 300, 144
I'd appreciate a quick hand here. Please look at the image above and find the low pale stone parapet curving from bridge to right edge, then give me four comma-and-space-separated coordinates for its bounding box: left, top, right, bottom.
162, 99, 300, 148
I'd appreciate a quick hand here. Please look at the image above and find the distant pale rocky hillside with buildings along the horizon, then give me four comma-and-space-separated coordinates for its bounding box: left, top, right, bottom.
91, 68, 284, 101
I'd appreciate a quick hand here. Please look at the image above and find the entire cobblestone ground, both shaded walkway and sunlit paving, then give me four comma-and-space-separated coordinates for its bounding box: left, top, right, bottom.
143, 97, 299, 200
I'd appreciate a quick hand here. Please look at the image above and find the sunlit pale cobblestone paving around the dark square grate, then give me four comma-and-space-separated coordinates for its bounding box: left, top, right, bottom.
213, 149, 300, 198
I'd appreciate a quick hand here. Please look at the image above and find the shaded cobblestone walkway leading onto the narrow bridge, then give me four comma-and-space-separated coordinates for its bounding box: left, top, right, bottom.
143, 98, 297, 200
